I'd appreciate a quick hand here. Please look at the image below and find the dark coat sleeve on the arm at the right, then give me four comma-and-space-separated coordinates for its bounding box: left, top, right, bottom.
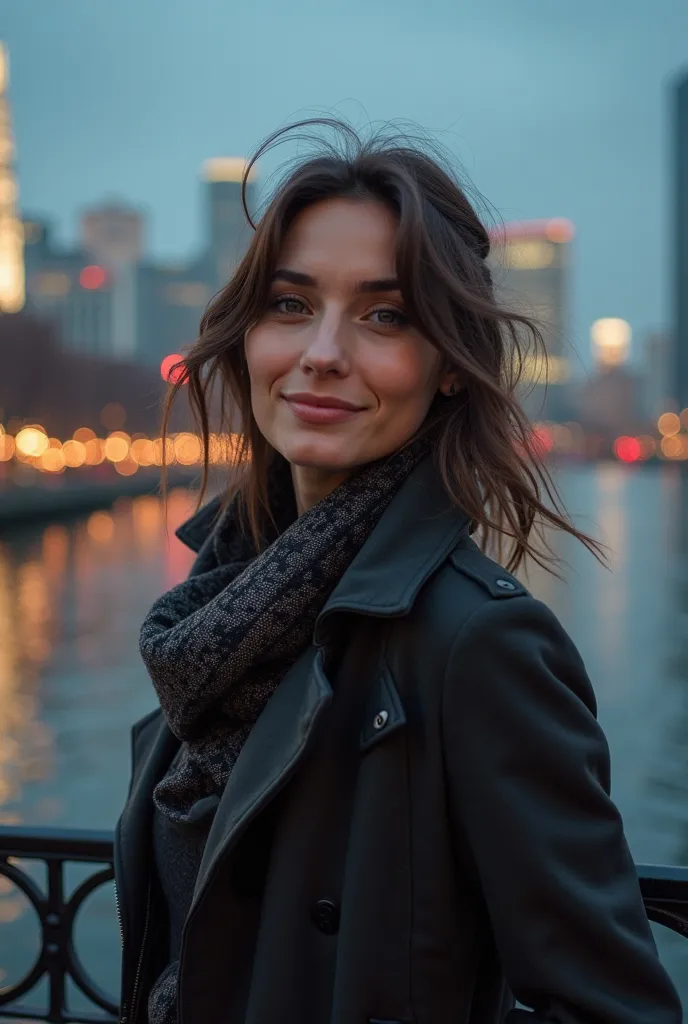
442, 595, 683, 1024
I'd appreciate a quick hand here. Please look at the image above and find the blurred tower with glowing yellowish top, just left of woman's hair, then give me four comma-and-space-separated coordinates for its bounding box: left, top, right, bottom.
203, 157, 259, 290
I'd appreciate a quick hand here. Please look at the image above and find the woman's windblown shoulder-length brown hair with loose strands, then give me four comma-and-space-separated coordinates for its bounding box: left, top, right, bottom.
163, 118, 603, 571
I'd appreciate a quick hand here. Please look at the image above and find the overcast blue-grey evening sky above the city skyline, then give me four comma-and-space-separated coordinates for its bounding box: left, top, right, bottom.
0, 0, 688, 362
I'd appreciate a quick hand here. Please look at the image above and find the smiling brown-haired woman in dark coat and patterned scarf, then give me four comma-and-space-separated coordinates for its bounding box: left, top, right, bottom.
116, 117, 681, 1024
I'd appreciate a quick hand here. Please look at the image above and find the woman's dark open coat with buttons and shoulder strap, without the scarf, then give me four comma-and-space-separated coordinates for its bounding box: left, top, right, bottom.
116, 460, 682, 1024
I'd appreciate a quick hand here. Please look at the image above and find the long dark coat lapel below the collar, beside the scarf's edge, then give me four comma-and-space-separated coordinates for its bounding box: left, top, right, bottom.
191, 647, 333, 909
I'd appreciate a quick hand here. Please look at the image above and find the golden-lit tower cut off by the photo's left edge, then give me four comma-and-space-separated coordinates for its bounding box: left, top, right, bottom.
0, 43, 25, 313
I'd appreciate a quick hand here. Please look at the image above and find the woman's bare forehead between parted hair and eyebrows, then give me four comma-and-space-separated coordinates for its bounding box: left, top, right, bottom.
280, 199, 396, 282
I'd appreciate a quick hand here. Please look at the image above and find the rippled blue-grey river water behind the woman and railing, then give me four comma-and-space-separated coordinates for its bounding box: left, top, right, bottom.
0, 464, 688, 1009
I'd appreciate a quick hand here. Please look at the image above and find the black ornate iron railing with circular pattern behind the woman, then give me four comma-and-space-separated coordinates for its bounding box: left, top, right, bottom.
0, 826, 688, 1024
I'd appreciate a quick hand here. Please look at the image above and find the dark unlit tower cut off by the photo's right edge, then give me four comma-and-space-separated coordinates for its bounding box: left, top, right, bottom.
671, 75, 688, 412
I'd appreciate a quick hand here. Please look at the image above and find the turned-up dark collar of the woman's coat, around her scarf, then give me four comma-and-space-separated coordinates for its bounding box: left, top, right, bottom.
176, 455, 470, 644
